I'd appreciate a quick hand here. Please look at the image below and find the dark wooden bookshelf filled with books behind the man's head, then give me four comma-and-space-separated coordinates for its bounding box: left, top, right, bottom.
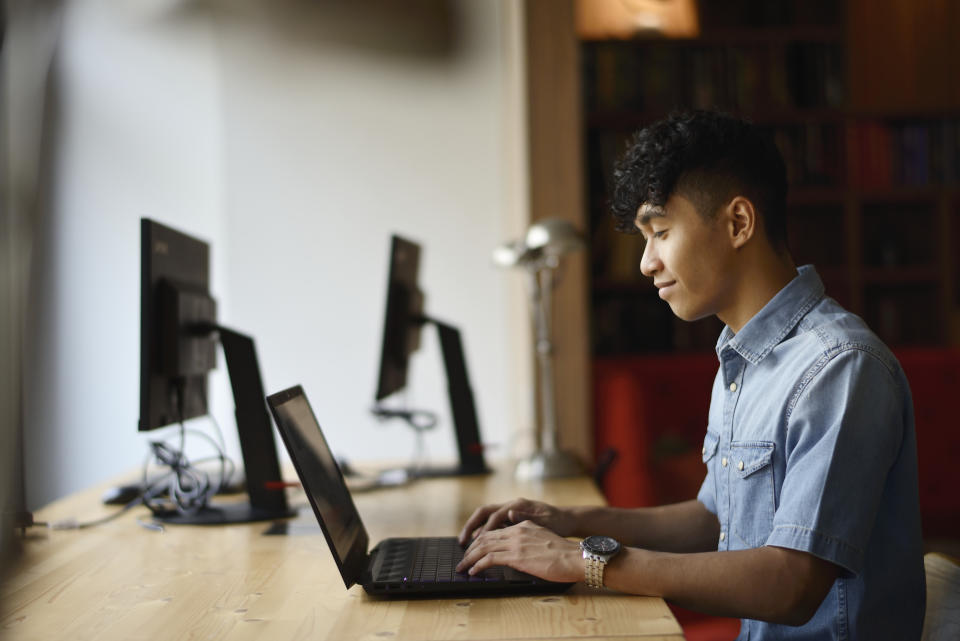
581, 0, 960, 357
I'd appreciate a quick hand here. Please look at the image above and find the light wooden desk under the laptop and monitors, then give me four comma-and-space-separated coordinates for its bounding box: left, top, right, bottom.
0, 464, 683, 641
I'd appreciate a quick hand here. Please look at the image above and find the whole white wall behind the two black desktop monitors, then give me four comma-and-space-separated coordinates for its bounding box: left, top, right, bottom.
26, 0, 529, 507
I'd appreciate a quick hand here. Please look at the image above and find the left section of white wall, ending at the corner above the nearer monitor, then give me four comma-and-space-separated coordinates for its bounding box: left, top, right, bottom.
24, 0, 227, 507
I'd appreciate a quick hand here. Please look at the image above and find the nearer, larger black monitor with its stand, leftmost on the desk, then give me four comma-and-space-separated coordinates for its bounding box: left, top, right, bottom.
139, 218, 293, 525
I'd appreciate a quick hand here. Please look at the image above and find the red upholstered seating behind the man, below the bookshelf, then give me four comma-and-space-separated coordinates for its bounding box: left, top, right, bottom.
593, 348, 960, 641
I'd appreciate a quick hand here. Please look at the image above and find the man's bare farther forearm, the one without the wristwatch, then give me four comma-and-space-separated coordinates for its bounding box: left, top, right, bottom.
571, 500, 720, 552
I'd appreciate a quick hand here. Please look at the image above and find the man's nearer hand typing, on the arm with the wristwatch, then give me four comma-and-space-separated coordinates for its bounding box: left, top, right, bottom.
457, 521, 583, 583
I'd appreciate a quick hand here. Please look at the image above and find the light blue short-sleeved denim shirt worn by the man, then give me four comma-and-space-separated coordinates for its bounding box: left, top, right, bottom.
697, 265, 926, 641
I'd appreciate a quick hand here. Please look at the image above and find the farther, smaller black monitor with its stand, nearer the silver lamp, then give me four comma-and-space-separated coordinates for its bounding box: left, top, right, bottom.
374, 235, 489, 476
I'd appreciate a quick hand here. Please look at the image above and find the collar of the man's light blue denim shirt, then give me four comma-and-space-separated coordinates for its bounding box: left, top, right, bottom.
716, 265, 825, 365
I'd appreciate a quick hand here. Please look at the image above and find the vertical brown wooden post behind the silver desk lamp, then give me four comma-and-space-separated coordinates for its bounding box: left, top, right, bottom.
523, 0, 594, 468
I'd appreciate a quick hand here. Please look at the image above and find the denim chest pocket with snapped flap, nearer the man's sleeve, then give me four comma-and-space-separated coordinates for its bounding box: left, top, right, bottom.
729, 441, 776, 548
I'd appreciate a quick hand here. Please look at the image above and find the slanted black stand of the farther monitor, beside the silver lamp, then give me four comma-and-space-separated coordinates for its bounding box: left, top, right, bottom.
416, 318, 490, 477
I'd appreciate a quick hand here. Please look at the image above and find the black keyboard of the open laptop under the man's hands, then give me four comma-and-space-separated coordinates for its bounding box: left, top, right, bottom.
375, 537, 533, 583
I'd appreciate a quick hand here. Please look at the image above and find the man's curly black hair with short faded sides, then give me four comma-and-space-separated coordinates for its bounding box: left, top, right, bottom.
611, 110, 787, 251
